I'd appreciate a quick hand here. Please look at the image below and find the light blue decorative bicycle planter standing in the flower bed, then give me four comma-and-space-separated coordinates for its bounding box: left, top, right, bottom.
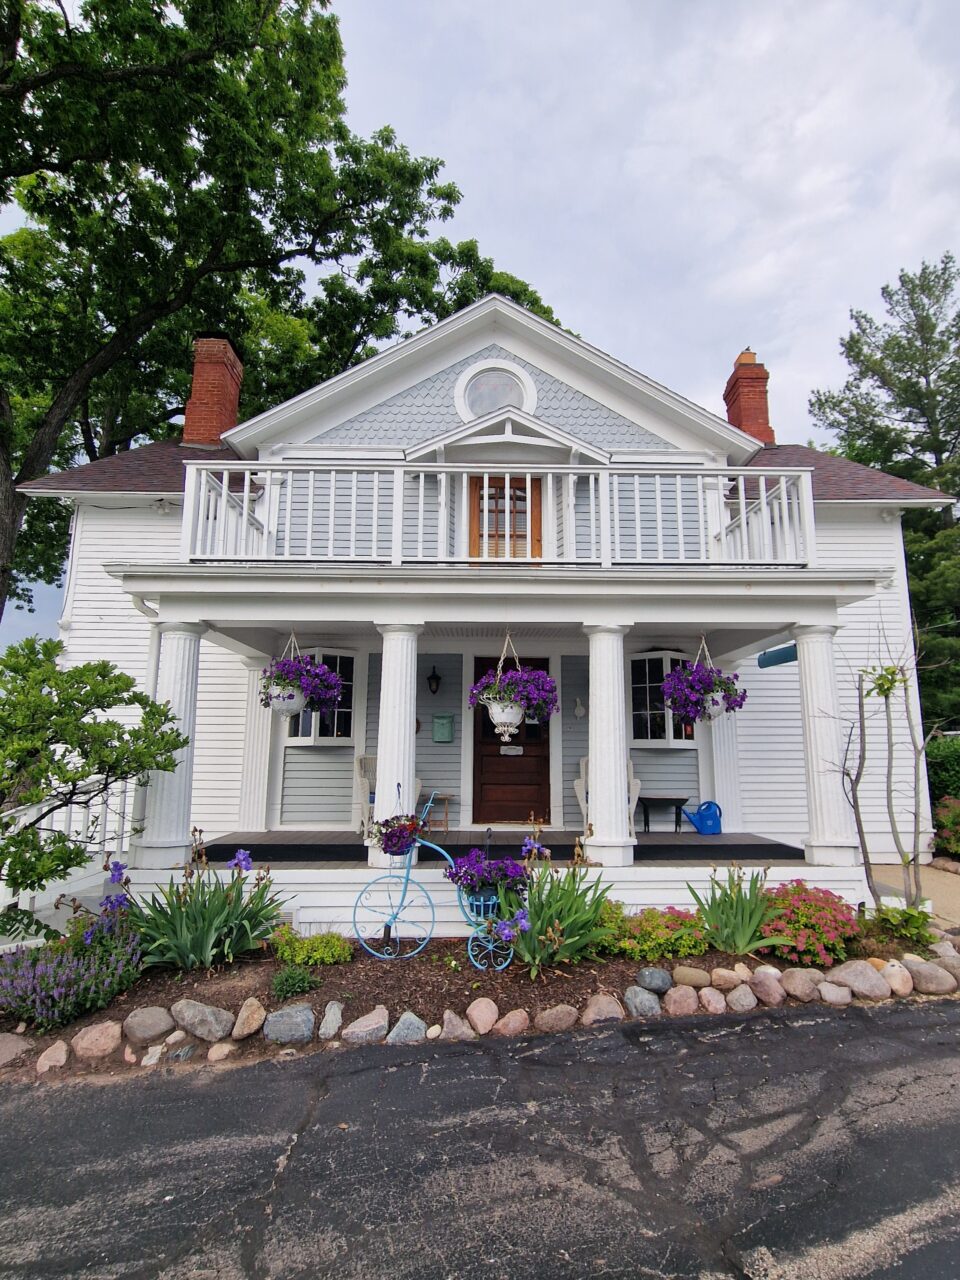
353, 795, 522, 970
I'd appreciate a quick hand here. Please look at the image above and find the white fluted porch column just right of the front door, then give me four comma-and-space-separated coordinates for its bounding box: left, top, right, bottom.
584, 626, 634, 867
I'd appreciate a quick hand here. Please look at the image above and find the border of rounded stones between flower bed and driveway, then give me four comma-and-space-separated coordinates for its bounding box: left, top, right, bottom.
20, 934, 960, 1076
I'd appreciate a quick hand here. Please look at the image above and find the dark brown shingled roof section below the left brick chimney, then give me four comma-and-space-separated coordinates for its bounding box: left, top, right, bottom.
19, 440, 237, 498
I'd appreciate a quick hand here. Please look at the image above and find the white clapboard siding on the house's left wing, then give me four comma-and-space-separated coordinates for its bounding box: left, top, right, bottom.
63, 502, 247, 838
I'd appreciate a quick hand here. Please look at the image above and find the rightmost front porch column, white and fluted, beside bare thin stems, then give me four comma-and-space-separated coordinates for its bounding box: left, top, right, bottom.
794, 626, 860, 867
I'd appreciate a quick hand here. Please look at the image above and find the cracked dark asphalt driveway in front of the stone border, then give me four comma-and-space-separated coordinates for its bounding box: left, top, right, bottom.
0, 1001, 960, 1280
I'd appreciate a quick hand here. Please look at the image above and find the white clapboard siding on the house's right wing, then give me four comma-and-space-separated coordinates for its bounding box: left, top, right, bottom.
736, 504, 929, 855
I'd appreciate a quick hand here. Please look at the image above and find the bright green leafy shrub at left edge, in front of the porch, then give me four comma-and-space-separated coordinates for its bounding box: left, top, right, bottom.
0, 639, 187, 936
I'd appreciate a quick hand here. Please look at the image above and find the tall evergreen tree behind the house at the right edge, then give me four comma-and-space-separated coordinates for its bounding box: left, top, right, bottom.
810, 253, 960, 728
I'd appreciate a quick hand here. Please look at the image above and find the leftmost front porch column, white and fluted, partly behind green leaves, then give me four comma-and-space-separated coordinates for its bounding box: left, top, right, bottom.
132, 622, 206, 867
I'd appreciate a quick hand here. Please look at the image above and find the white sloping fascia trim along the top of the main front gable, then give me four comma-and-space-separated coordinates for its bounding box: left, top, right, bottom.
223, 294, 758, 465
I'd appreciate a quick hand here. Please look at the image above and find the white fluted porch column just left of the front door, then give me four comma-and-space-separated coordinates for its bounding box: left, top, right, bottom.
369, 622, 422, 867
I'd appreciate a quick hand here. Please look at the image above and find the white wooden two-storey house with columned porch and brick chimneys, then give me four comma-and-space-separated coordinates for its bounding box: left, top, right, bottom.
26, 297, 947, 925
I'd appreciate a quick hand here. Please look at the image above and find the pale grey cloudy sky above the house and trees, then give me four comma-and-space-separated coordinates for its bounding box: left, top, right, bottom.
0, 0, 960, 643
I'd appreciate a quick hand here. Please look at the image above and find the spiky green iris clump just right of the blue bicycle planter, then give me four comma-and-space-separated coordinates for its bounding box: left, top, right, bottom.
499, 867, 609, 978
